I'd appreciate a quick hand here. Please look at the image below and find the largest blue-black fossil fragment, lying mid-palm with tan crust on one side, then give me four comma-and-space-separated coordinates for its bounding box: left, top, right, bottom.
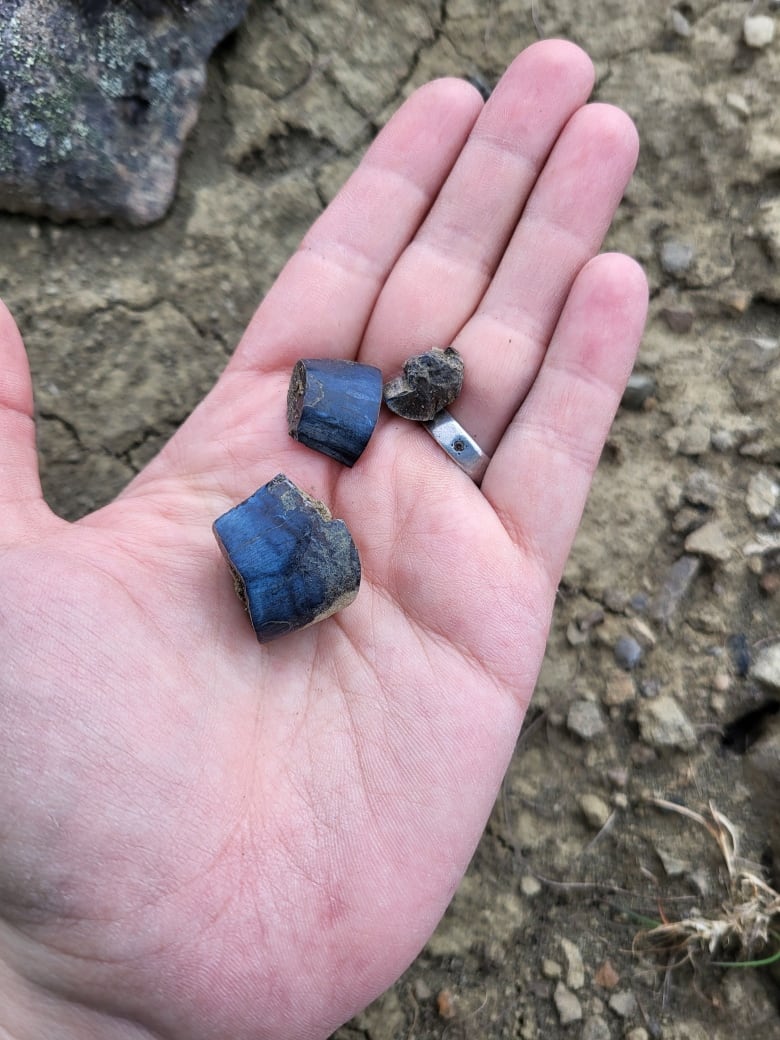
213, 473, 360, 643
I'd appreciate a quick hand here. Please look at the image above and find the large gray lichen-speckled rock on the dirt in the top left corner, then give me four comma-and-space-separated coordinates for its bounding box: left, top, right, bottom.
0, 0, 249, 225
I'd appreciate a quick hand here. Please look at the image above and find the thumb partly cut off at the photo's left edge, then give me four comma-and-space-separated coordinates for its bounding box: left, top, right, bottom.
0, 301, 50, 546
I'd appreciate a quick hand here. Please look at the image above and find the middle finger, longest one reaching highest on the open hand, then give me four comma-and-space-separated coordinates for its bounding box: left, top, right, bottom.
361, 41, 594, 369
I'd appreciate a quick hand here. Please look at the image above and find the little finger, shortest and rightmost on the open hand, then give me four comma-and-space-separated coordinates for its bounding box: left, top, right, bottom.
482, 248, 647, 588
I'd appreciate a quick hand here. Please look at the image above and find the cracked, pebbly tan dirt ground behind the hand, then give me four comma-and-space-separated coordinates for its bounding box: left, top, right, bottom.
0, 0, 780, 1040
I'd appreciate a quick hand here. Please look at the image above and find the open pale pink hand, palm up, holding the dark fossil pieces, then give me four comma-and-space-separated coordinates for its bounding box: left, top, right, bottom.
0, 42, 647, 1040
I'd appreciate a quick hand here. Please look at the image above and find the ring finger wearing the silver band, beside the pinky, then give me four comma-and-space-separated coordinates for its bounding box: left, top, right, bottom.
452, 104, 639, 454
